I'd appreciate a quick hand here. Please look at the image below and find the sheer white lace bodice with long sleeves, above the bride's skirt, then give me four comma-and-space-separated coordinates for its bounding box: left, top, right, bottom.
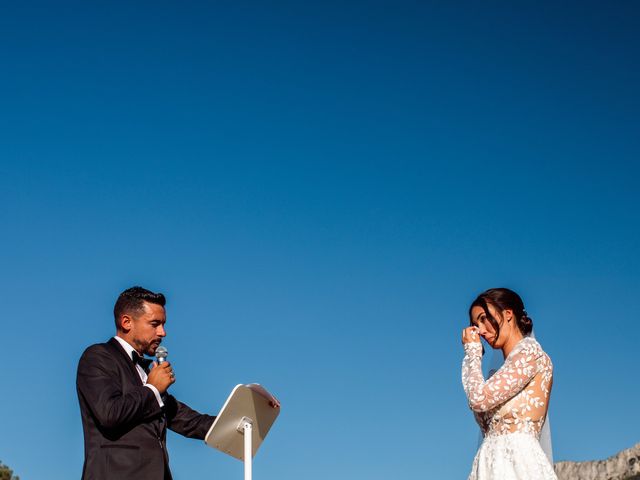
462, 337, 553, 437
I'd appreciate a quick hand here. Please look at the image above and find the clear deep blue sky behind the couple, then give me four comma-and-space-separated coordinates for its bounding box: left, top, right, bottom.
0, 1, 640, 480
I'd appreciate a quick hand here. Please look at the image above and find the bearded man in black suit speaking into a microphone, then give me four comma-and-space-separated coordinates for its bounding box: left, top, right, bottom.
76, 287, 215, 480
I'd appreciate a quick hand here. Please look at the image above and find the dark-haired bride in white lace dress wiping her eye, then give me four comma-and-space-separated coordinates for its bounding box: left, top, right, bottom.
462, 288, 557, 480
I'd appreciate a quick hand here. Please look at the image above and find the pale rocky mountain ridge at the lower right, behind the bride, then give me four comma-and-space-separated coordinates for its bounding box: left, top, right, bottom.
554, 443, 640, 480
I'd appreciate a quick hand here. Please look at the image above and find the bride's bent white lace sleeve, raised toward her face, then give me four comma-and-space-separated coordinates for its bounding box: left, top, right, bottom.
462, 339, 542, 412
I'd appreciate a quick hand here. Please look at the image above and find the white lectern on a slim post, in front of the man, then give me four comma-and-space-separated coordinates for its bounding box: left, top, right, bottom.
204, 384, 280, 480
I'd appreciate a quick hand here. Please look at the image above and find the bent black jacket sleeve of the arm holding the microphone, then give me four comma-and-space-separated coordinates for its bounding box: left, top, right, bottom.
77, 346, 162, 429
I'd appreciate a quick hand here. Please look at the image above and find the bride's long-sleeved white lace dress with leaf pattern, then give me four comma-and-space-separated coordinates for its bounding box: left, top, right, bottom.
462, 337, 557, 480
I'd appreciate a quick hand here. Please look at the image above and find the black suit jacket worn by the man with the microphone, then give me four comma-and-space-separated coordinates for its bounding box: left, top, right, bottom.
76, 338, 215, 480
